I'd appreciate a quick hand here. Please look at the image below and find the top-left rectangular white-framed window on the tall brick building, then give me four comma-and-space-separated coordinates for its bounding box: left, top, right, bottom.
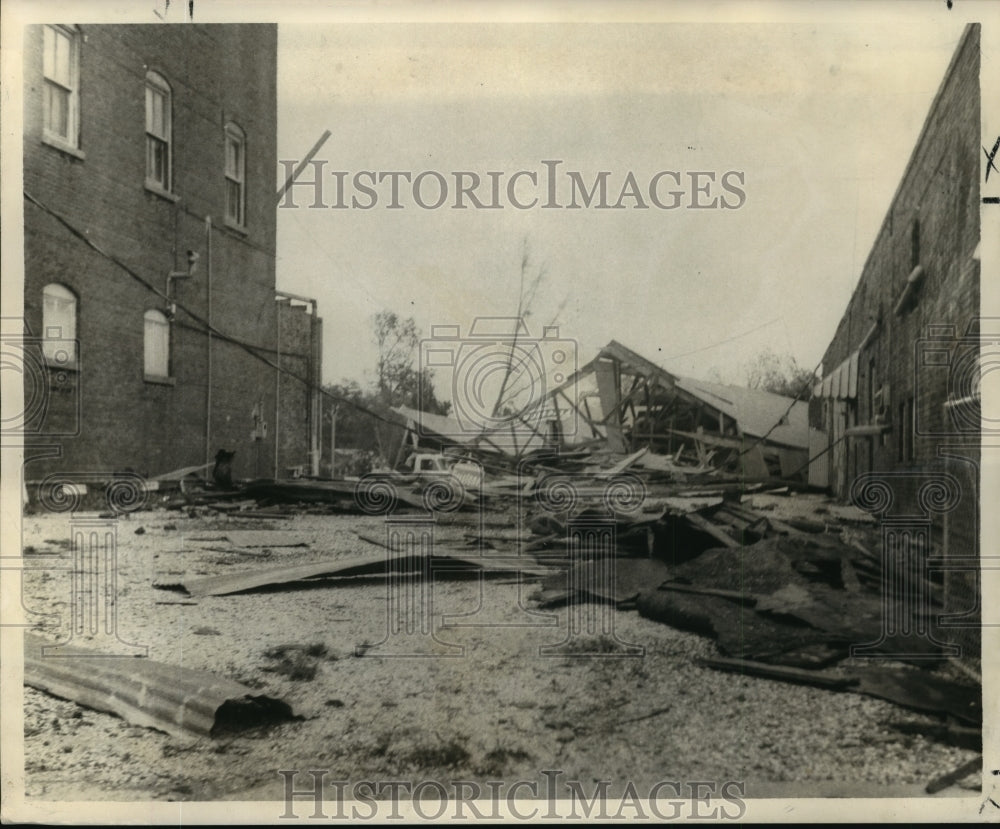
42, 26, 80, 147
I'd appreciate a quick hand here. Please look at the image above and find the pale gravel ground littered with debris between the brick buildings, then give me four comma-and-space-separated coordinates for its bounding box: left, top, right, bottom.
13, 498, 979, 804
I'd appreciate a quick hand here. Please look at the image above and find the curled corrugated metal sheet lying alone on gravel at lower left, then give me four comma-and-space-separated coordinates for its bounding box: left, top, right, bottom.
24, 633, 293, 737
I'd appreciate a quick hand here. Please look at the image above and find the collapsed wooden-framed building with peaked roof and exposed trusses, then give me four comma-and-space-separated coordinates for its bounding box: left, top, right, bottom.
386, 340, 825, 482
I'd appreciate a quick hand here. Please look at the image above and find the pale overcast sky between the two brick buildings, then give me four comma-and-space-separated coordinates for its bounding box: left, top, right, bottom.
278, 9, 976, 397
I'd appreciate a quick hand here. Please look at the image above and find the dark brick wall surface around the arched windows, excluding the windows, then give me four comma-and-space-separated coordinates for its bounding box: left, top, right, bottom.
24, 24, 306, 479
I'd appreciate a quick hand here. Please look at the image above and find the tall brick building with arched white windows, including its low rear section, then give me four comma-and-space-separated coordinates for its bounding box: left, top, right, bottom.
24, 24, 321, 481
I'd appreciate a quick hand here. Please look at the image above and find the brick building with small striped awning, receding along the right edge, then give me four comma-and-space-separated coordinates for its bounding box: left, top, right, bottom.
811, 24, 982, 668
